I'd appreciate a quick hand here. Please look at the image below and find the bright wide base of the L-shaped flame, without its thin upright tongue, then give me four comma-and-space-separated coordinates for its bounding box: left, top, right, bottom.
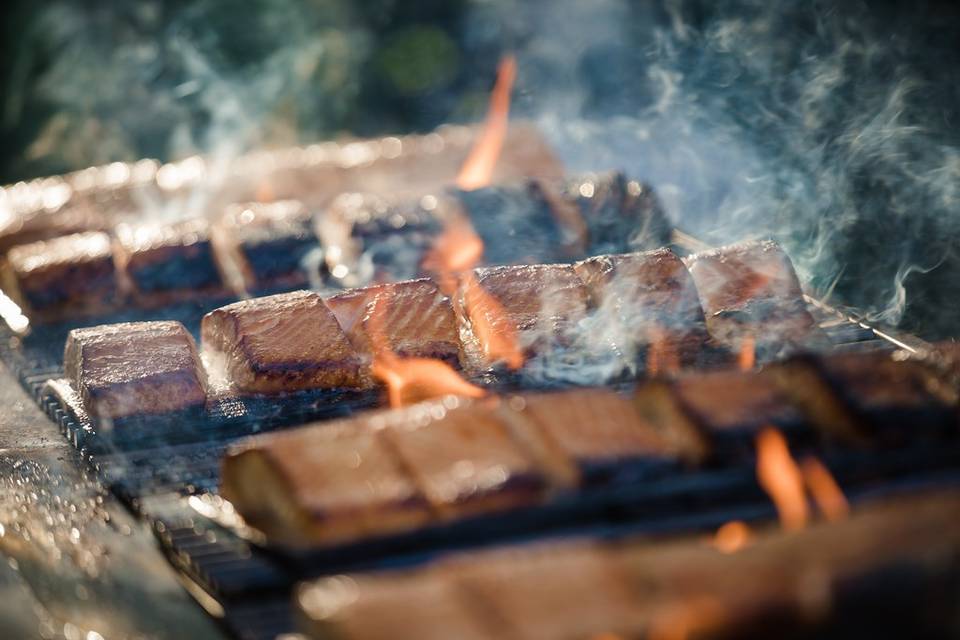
371, 351, 486, 407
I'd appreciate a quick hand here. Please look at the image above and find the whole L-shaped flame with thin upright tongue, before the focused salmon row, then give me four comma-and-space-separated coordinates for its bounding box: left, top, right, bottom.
367, 297, 486, 407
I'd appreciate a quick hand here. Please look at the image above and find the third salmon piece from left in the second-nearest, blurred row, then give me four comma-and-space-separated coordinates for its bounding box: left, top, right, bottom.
504, 389, 699, 485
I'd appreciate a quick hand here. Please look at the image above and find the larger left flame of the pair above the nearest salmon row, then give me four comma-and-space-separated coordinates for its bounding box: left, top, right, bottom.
757, 427, 810, 531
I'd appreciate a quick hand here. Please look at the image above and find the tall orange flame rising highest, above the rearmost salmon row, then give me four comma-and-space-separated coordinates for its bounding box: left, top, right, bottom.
457, 56, 517, 191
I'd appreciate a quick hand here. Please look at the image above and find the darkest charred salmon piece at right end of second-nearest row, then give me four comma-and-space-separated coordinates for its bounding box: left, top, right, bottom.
777, 351, 957, 445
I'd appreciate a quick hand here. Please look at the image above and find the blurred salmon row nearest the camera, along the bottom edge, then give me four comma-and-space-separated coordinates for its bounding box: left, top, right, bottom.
296, 491, 960, 640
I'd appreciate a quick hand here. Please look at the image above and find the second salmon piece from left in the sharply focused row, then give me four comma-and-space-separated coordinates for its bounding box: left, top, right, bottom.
200, 291, 367, 394
